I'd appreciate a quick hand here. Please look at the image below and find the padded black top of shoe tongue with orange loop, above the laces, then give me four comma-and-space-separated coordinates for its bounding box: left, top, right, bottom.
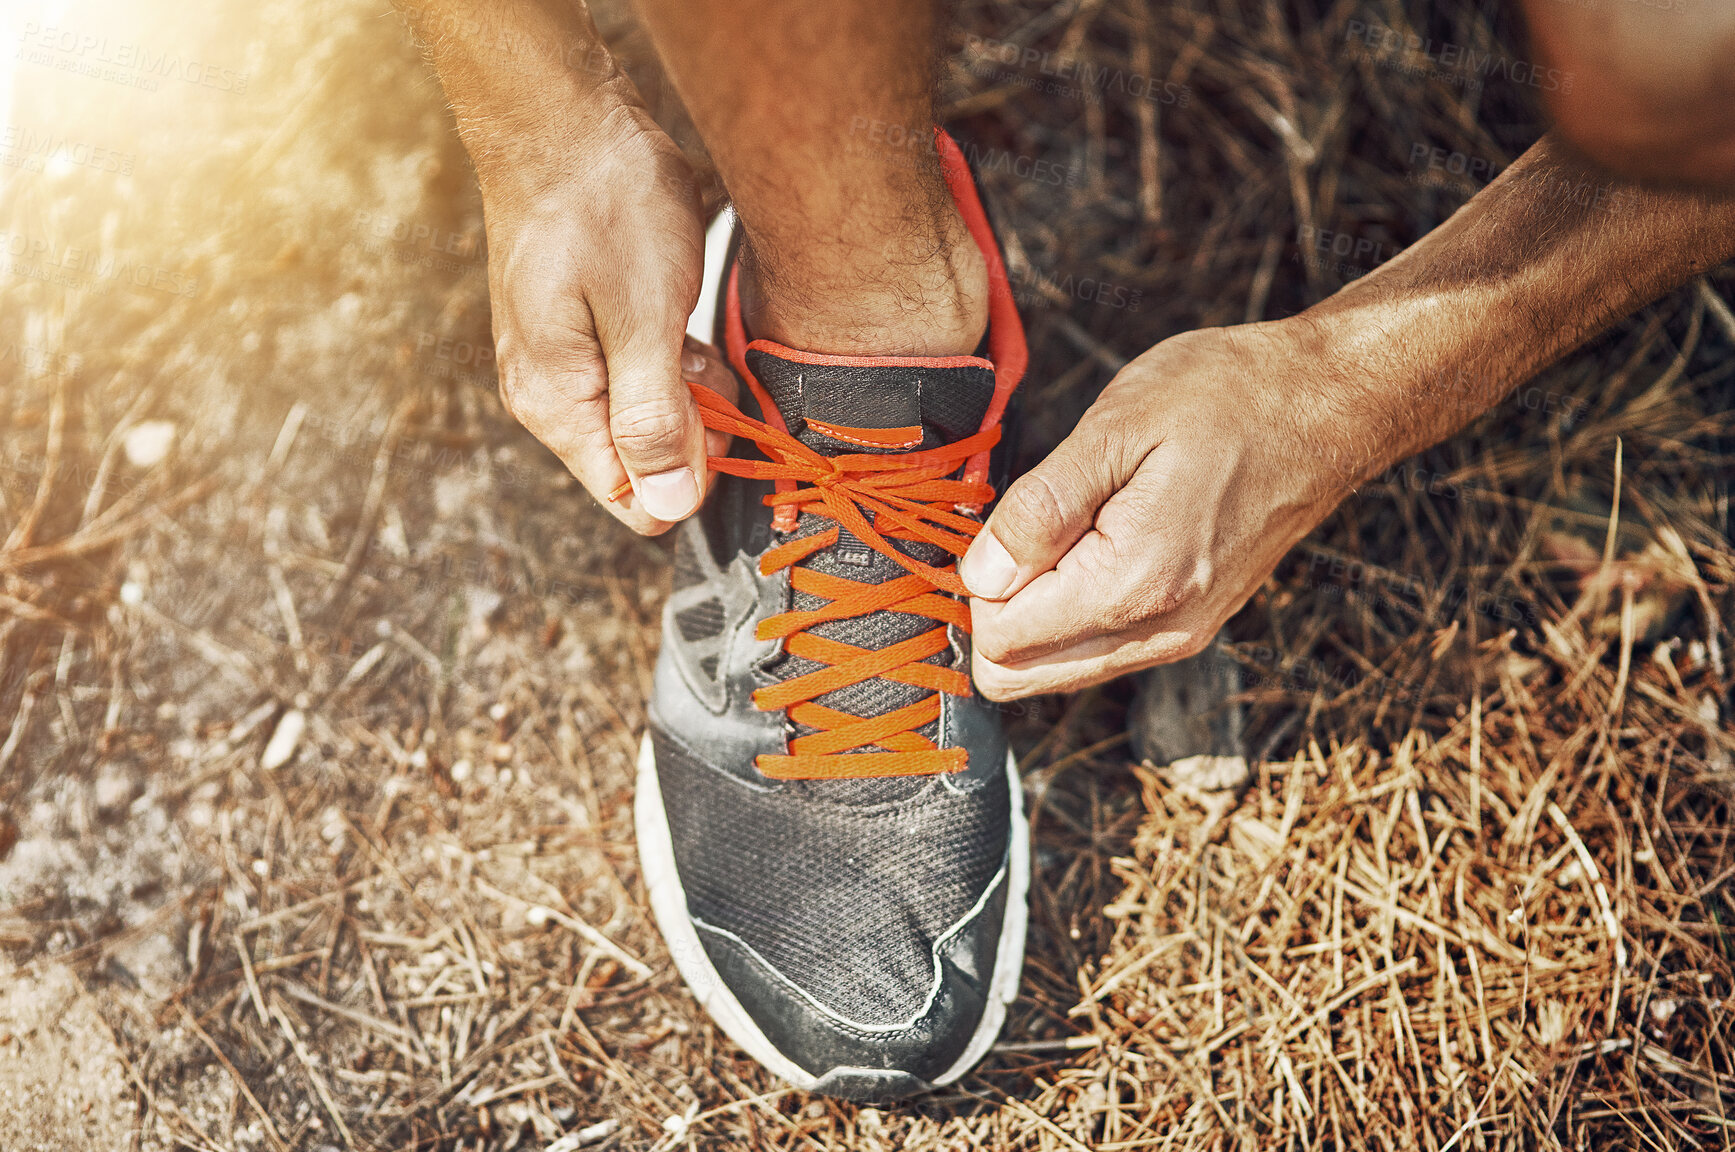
748, 342, 994, 456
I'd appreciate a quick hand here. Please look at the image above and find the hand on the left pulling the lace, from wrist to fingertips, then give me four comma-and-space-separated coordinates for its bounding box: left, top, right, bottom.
482, 104, 734, 534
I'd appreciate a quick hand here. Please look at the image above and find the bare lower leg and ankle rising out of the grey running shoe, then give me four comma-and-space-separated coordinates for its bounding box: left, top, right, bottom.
638, 0, 987, 356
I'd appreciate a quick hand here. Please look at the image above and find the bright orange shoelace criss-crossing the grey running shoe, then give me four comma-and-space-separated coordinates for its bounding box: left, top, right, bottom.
687, 383, 999, 781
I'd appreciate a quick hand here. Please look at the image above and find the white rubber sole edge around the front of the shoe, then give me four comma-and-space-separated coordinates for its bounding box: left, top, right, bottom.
633, 732, 1031, 1091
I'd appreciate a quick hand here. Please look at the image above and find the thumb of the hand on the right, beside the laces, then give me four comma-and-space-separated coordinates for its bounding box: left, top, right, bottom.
958, 425, 1131, 600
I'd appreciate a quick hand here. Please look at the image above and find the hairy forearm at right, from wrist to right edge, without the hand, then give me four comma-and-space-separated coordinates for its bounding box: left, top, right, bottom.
1296, 137, 1735, 484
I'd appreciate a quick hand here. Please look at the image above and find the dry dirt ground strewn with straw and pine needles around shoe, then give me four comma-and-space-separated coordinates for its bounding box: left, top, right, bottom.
0, 0, 1735, 1152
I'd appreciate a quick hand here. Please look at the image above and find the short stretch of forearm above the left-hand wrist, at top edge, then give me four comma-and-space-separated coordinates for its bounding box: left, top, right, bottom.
394, 0, 637, 193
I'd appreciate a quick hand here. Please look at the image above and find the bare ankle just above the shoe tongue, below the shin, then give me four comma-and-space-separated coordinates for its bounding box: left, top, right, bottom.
741, 210, 989, 356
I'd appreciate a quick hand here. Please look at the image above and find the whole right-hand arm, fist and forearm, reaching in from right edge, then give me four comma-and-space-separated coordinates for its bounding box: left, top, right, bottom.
961, 131, 1735, 699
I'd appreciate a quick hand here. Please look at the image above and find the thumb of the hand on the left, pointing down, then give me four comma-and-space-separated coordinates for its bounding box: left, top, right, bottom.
599, 315, 704, 522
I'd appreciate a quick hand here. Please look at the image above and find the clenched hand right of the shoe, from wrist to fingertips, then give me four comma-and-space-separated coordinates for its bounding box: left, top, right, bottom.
961, 323, 1348, 699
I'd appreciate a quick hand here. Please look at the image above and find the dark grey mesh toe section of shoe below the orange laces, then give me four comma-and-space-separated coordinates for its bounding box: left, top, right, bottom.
656, 732, 1008, 1027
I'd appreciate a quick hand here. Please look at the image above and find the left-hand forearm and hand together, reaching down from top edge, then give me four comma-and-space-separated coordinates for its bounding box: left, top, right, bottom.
401, 0, 736, 534
